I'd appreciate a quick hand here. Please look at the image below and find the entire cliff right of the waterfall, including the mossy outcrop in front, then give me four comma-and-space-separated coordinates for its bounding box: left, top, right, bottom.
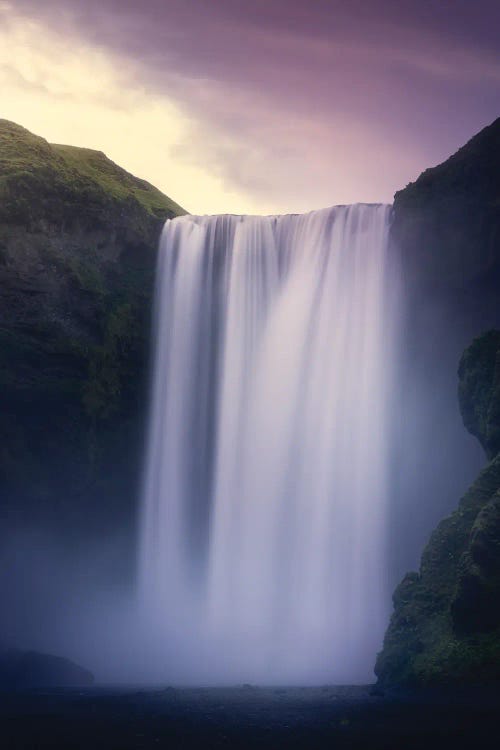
376, 119, 500, 684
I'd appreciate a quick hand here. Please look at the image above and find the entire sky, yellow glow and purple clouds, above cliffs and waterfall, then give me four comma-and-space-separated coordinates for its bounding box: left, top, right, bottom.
0, 0, 500, 215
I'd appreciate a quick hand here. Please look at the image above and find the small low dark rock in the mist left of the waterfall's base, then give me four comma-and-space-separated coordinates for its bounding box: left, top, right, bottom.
0, 649, 94, 690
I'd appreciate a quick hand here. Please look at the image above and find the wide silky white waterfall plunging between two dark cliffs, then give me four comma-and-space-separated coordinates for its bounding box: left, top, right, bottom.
141, 205, 394, 683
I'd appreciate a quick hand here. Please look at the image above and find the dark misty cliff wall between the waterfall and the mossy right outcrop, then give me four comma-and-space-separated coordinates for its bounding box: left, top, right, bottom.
390, 119, 500, 578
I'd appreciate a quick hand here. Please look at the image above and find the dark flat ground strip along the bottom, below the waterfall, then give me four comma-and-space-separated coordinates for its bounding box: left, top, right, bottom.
0, 686, 500, 750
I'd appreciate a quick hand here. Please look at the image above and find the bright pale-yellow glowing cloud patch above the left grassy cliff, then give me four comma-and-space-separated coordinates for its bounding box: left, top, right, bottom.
0, 4, 262, 212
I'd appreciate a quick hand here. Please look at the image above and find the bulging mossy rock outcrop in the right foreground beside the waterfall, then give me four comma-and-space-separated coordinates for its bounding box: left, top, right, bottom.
375, 331, 500, 684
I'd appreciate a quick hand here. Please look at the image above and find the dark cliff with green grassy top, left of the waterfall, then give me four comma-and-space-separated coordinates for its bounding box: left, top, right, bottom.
0, 120, 184, 538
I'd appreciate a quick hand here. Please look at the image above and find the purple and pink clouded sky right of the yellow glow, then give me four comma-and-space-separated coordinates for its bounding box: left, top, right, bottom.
4, 0, 500, 211
